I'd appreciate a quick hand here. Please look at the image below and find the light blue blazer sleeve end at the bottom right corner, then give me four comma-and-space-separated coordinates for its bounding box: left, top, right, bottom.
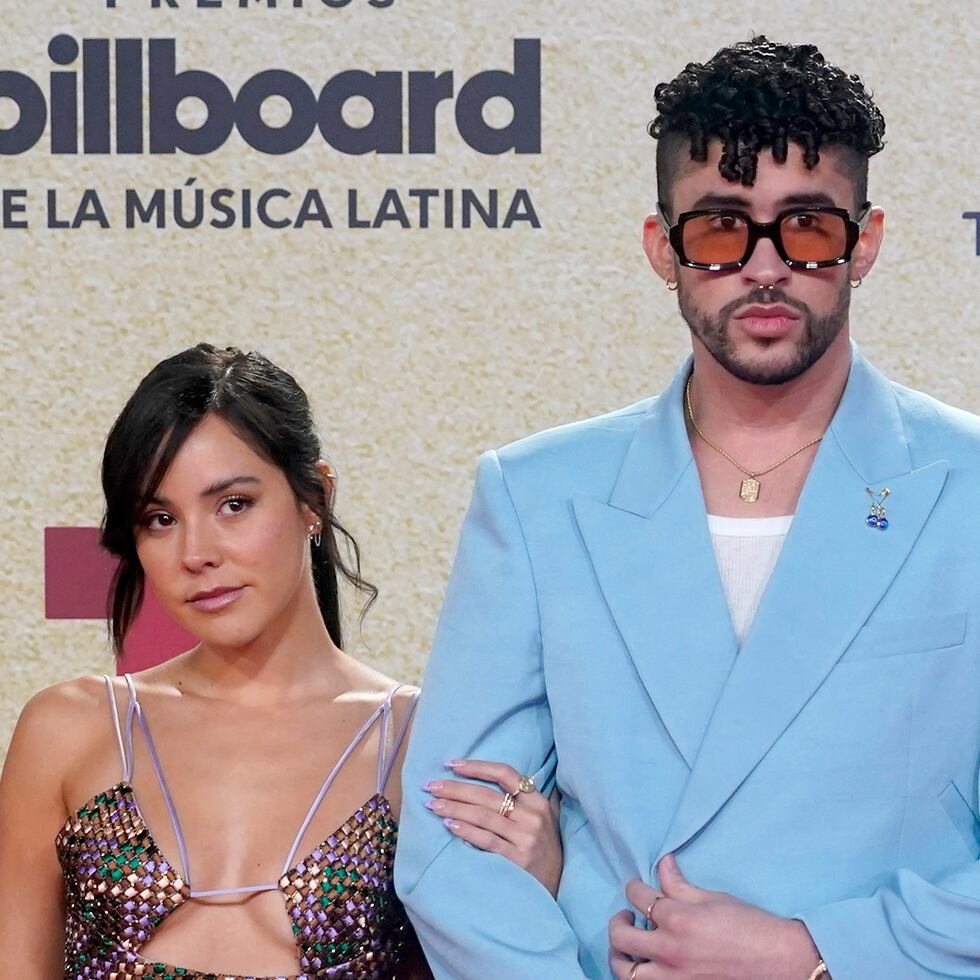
797, 800, 980, 980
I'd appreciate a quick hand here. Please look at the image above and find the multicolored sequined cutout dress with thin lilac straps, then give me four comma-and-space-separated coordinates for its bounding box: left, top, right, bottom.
55, 674, 416, 980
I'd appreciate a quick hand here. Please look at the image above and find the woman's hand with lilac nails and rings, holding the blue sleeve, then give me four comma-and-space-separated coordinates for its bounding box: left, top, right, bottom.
423, 759, 562, 896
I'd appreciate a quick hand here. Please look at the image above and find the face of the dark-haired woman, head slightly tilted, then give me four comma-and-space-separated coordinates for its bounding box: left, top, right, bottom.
135, 415, 317, 647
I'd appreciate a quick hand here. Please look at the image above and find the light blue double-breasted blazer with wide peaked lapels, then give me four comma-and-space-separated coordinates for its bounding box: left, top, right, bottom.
395, 348, 980, 980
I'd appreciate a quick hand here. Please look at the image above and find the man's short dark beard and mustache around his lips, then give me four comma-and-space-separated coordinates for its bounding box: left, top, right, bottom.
677, 283, 851, 385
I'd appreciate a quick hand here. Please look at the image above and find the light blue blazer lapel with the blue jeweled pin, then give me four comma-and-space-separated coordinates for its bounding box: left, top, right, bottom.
658, 349, 947, 859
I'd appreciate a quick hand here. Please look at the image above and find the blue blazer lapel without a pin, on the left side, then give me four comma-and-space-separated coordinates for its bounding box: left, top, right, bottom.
572, 361, 737, 766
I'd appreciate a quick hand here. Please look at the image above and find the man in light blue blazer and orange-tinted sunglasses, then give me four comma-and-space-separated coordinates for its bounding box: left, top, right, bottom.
396, 37, 980, 980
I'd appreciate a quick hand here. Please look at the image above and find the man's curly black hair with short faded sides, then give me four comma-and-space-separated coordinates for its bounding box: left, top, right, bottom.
648, 35, 885, 211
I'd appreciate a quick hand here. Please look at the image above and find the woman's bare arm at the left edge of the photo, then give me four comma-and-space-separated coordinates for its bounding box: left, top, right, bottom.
0, 688, 75, 980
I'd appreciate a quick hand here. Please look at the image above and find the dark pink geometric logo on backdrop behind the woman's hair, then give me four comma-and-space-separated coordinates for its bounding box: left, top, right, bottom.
44, 527, 197, 674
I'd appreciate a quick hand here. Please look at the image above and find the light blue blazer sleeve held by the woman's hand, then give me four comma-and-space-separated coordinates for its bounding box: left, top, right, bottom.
395, 452, 585, 980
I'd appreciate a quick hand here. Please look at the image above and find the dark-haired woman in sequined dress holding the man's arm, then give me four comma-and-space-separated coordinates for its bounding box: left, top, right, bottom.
0, 344, 560, 980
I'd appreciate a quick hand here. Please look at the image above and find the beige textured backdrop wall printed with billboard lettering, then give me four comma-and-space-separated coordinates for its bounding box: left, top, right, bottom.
0, 0, 980, 755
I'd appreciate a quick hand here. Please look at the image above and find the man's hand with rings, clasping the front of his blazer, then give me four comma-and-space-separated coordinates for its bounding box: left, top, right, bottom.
609, 854, 820, 980
